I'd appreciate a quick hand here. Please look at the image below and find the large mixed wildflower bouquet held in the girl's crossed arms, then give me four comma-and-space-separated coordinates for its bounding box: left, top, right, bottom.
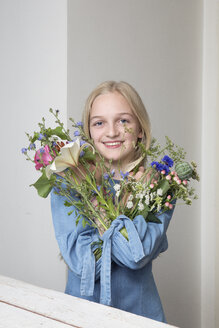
22, 109, 199, 252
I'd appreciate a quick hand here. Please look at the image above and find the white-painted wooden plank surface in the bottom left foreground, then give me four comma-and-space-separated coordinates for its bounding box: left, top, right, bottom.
0, 276, 178, 328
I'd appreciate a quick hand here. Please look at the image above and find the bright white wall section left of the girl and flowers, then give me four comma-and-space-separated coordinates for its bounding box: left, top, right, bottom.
0, 0, 67, 290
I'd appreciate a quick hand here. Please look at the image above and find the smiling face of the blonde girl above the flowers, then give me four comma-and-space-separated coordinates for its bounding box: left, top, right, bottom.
89, 92, 142, 169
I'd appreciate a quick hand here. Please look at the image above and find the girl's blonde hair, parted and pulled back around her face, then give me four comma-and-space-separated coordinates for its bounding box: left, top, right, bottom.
83, 81, 151, 157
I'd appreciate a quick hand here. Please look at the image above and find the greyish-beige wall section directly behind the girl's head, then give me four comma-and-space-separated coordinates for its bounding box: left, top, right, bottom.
68, 0, 203, 328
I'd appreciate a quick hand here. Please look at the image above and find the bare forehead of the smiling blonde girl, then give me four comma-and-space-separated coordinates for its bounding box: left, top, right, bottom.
90, 92, 133, 117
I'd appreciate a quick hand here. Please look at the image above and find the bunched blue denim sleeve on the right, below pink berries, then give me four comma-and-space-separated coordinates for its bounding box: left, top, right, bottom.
104, 206, 173, 270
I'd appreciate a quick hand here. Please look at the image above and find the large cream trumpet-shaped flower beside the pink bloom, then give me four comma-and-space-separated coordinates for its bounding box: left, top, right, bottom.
46, 139, 95, 179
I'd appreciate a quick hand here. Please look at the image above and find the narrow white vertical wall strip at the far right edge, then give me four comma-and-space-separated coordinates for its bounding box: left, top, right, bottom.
201, 0, 219, 328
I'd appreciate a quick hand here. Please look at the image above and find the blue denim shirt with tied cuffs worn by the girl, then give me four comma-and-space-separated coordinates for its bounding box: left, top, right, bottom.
51, 191, 173, 322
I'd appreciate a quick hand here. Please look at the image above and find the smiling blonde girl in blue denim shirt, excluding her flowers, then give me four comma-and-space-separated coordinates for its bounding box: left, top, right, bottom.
51, 81, 173, 322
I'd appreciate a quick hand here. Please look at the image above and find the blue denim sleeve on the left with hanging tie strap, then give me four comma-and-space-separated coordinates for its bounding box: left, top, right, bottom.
51, 190, 100, 296
